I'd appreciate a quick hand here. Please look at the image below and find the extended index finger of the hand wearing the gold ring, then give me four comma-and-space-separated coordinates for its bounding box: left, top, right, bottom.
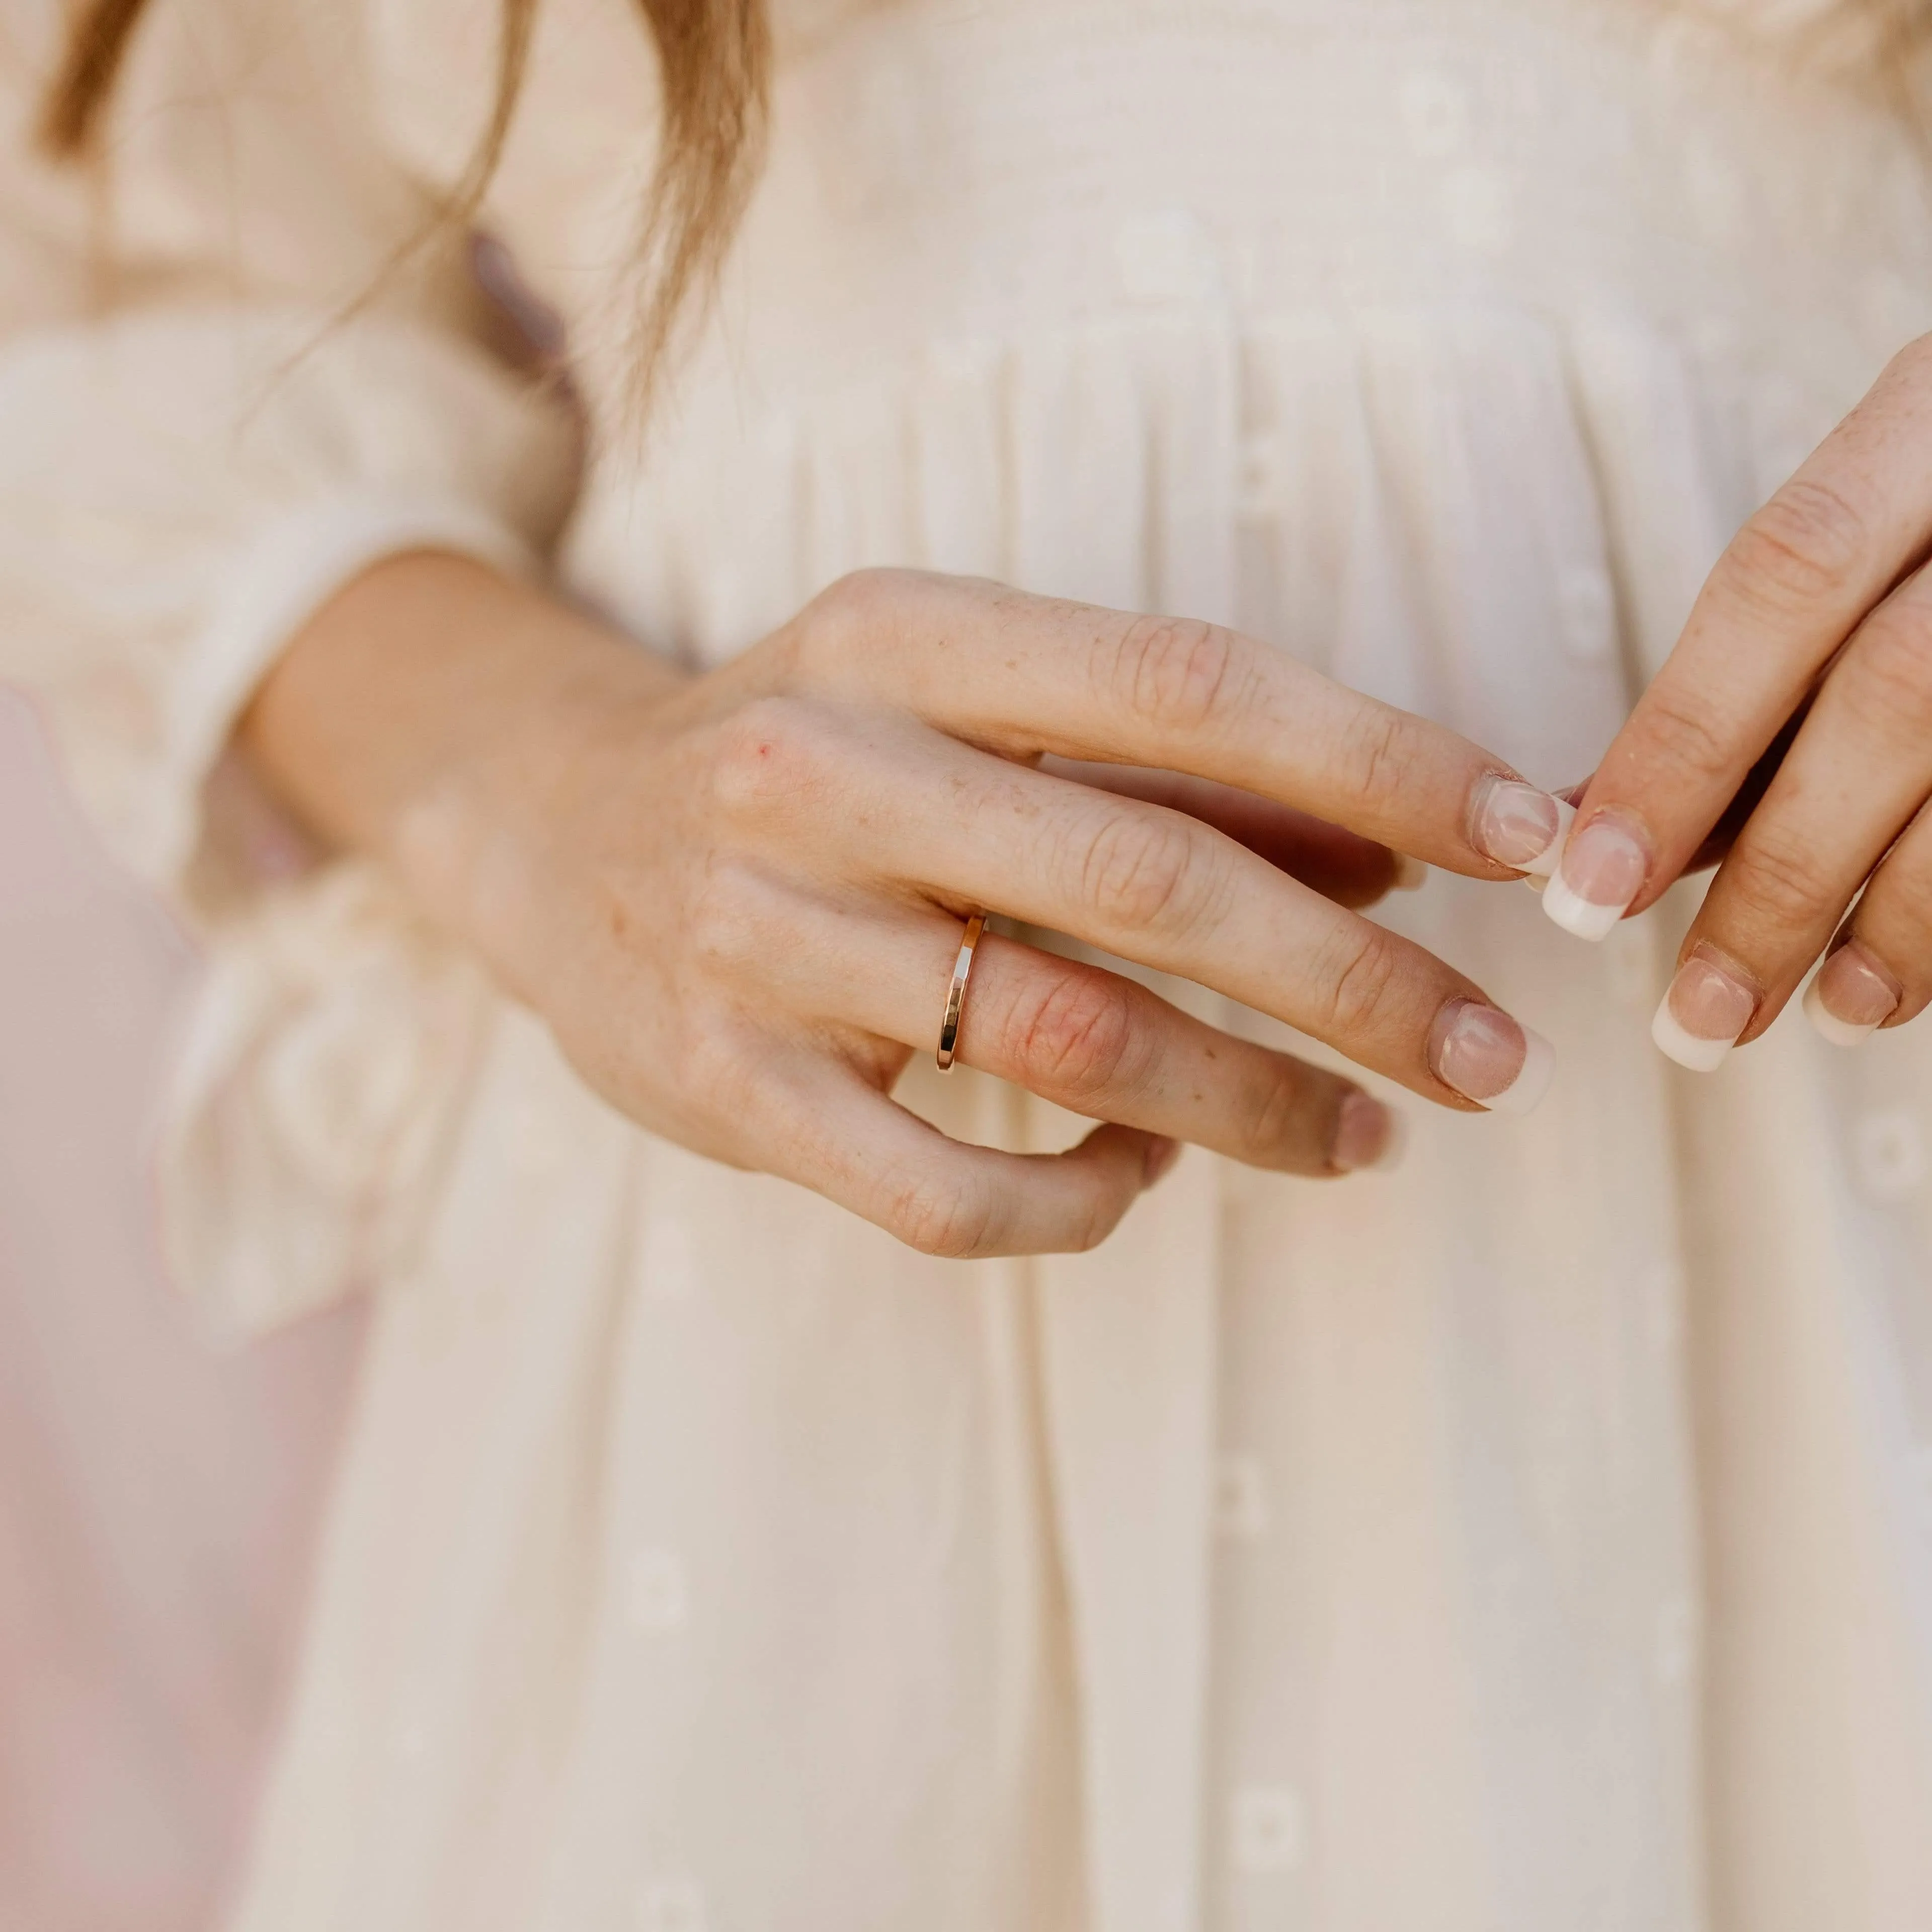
784, 572, 1567, 879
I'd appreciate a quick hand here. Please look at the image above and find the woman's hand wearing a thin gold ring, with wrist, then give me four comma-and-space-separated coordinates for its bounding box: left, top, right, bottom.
246, 556, 1557, 1256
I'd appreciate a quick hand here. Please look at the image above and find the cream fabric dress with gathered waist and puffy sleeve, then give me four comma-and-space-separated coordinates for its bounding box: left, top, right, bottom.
0, 0, 1932, 1932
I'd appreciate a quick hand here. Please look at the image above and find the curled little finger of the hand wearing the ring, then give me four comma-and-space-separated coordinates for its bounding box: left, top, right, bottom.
775, 1065, 1180, 1260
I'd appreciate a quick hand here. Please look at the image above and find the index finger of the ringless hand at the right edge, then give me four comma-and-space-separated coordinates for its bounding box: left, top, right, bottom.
1544, 336, 1932, 939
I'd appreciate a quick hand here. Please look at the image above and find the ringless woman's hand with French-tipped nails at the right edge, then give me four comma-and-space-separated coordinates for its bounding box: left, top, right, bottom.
1544, 336, 1932, 1070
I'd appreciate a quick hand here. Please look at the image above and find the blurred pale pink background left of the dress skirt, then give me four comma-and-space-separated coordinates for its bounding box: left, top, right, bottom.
0, 692, 359, 1932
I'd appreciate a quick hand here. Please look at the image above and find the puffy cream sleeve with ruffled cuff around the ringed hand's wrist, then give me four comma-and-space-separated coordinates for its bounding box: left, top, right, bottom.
0, 0, 578, 1325
